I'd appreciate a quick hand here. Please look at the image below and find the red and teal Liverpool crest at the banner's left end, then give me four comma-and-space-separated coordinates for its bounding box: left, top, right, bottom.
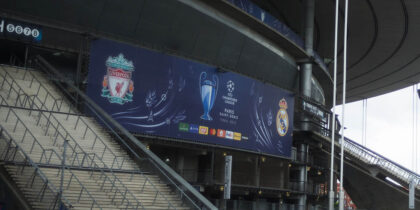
102, 53, 134, 105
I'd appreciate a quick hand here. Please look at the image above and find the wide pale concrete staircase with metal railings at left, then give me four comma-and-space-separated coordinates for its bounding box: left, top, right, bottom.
0, 57, 216, 210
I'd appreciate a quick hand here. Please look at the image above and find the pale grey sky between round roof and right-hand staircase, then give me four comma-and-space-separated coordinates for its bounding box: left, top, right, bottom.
336, 86, 420, 173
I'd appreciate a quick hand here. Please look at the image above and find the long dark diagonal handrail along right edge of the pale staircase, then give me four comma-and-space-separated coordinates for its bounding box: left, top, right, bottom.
35, 55, 217, 210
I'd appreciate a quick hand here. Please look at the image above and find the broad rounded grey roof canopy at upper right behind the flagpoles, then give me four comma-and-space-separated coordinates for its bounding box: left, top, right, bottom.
256, 0, 420, 101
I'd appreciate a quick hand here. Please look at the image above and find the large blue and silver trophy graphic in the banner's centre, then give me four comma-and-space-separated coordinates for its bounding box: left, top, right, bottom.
199, 72, 219, 120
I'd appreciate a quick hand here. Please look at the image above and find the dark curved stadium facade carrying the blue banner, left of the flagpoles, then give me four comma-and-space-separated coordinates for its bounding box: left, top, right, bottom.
0, 0, 418, 209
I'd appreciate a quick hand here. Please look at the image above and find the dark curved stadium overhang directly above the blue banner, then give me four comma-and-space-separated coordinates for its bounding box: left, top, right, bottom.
0, 0, 307, 92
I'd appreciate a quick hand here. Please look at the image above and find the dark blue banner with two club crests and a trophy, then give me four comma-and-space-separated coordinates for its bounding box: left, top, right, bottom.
87, 39, 294, 157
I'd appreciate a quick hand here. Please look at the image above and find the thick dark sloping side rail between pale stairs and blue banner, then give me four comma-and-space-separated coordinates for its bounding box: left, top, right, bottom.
35, 55, 217, 209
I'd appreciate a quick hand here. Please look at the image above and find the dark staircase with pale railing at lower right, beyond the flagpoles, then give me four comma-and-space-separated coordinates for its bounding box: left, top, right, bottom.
337, 138, 420, 210
